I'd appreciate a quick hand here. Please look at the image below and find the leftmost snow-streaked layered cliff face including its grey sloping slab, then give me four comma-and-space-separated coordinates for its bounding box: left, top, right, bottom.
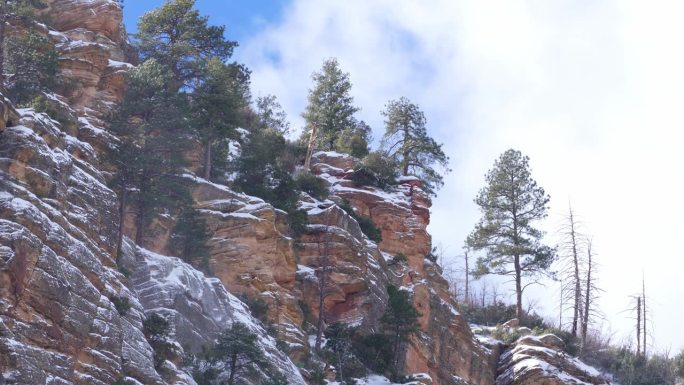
0, 0, 303, 385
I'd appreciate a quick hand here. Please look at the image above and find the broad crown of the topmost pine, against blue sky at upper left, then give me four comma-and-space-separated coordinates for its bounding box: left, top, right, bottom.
135, 0, 237, 88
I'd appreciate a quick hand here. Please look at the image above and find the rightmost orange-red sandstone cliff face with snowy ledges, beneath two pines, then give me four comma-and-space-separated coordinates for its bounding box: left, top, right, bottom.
312, 153, 498, 385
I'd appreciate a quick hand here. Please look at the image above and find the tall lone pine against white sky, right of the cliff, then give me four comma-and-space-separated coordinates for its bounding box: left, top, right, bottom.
467, 150, 556, 319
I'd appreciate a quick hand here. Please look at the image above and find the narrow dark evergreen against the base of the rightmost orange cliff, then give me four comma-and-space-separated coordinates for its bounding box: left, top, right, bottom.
380, 285, 420, 369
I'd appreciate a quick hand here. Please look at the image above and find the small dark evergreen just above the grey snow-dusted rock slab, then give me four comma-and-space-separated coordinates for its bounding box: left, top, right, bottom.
169, 207, 211, 272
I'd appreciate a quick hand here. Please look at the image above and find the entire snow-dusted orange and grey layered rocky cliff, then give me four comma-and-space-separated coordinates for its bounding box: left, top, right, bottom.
0, 0, 608, 385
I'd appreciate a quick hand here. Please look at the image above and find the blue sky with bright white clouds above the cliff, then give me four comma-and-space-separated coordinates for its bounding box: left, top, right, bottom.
125, 0, 684, 352
